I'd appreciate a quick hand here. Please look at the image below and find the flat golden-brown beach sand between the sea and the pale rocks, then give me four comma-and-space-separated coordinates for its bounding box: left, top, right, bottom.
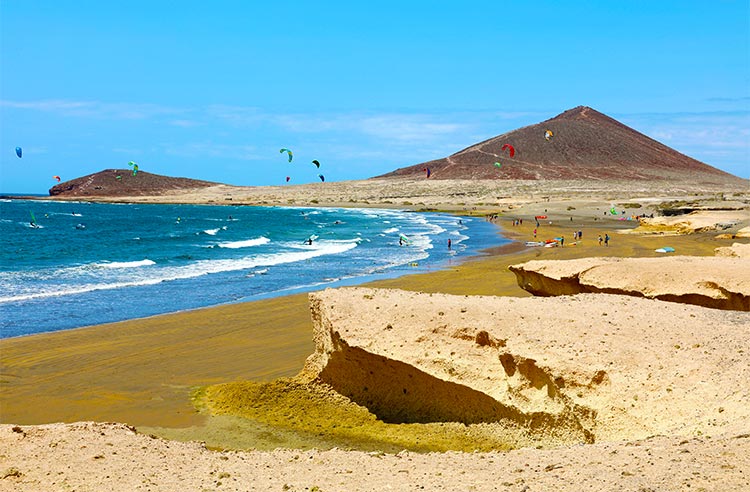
0, 213, 731, 449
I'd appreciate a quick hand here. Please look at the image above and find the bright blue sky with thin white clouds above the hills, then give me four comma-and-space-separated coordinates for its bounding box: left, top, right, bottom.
0, 0, 750, 193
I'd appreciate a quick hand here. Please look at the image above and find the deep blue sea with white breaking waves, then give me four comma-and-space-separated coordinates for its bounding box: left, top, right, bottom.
0, 200, 506, 338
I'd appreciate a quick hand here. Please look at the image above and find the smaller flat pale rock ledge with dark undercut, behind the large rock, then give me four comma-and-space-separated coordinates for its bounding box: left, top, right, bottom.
509, 256, 750, 311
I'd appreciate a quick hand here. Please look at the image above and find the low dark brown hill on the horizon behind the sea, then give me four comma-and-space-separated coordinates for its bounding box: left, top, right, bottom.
49, 169, 218, 197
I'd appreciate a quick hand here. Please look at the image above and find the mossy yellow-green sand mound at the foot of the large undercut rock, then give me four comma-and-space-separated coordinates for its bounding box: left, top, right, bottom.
195, 378, 512, 453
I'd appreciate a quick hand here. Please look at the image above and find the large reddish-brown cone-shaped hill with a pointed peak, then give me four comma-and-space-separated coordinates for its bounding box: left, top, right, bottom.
378, 106, 745, 186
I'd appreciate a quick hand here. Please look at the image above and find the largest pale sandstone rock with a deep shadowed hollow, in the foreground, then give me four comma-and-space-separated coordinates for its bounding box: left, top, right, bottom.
301, 288, 750, 445
